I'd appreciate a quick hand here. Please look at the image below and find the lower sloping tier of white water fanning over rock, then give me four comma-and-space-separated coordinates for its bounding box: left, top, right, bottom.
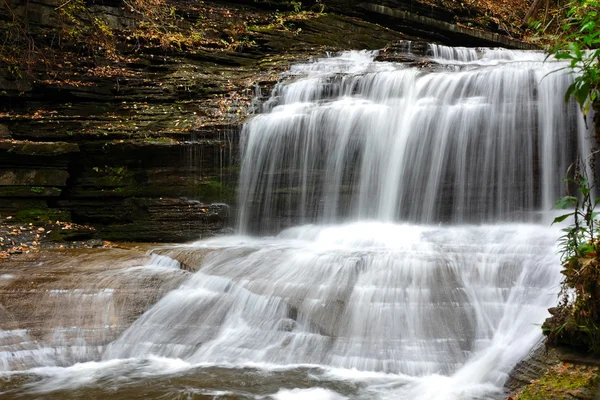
105, 222, 558, 383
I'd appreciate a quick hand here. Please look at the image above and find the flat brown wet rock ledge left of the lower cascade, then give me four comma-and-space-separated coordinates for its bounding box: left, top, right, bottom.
0, 245, 187, 370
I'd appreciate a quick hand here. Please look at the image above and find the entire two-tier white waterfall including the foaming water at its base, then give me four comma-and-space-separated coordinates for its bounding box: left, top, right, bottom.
0, 46, 588, 400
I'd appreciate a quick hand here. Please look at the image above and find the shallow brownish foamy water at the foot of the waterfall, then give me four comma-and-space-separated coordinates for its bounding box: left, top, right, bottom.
0, 358, 501, 400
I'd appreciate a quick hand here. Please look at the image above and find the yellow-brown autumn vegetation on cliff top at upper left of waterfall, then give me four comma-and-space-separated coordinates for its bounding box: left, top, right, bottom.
0, 0, 324, 86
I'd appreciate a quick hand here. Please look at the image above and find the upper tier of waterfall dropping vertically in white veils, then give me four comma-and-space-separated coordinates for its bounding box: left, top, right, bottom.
240, 46, 586, 232
